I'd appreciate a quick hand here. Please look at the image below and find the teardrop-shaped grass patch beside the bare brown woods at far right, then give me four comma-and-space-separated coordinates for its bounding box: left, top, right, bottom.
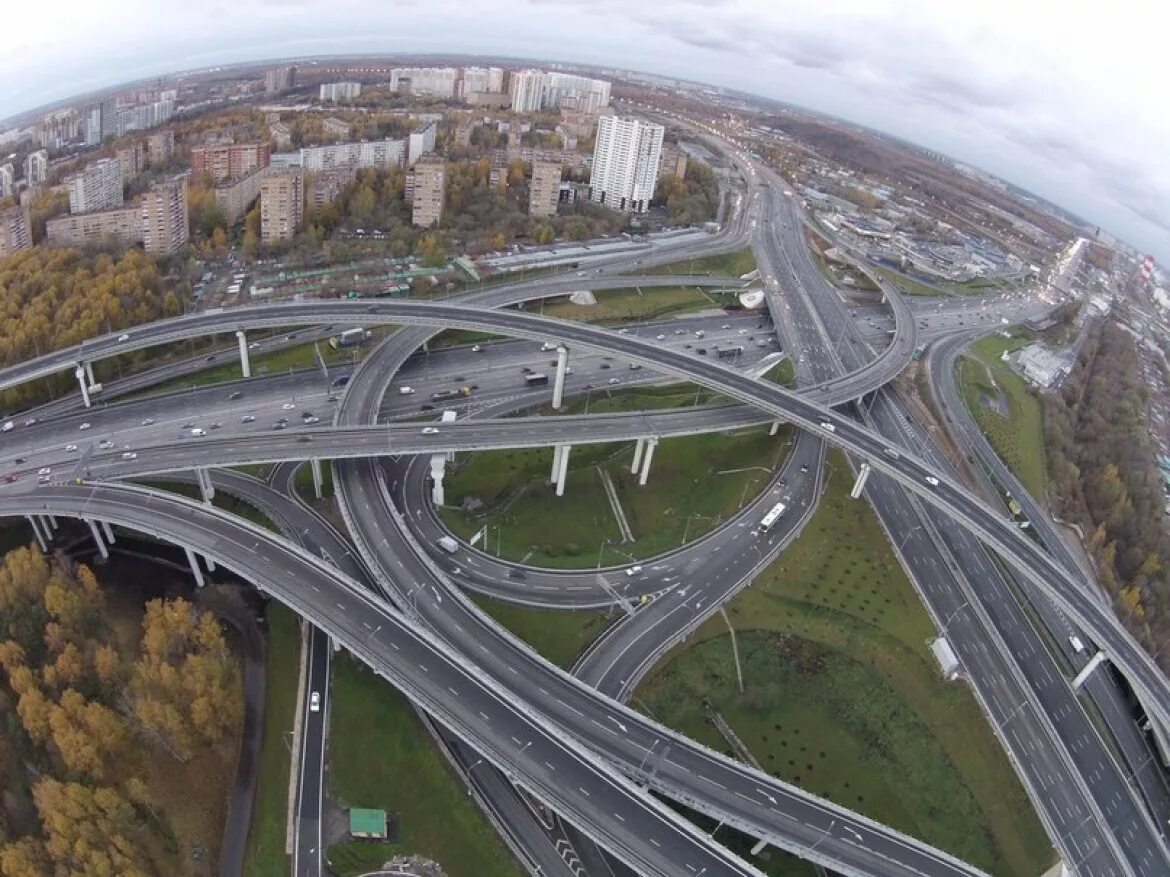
957, 334, 1047, 502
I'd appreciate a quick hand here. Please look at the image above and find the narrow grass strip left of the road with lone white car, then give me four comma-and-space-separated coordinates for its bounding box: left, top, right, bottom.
243, 601, 301, 877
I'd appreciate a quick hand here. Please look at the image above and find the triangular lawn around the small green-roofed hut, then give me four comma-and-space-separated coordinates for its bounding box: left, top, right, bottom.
329, 652, 521, 877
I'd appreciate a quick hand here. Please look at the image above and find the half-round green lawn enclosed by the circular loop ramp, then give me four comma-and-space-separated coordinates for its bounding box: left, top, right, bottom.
440, 423, 791, 569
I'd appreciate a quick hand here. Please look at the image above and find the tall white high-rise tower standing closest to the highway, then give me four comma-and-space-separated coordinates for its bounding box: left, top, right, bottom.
590, 116, 666, 213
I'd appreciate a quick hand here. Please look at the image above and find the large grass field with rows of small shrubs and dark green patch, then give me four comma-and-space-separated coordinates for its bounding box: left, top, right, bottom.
635, 453, 1054, 875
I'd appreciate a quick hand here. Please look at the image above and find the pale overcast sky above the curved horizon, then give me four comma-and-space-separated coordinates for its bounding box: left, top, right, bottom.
0, 0, 1170, 264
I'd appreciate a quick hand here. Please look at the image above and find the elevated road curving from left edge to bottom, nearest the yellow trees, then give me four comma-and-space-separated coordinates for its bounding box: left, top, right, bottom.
0, 485, 758, 876
